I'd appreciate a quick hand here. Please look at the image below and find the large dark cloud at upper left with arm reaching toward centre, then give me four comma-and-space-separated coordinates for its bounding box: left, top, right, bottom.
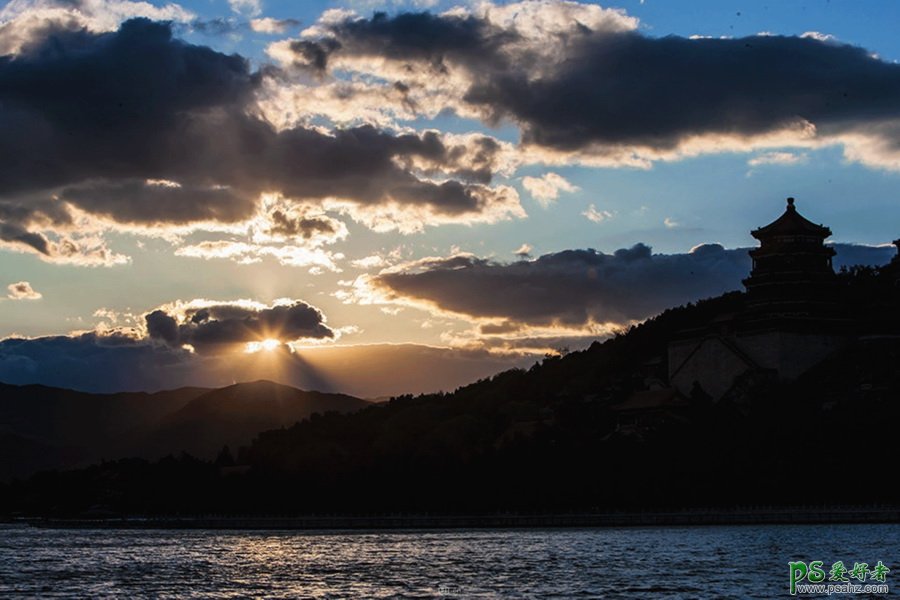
0, 19, 520, 253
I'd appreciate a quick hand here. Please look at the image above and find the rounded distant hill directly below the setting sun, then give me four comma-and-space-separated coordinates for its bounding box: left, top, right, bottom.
141, 381, 369, 457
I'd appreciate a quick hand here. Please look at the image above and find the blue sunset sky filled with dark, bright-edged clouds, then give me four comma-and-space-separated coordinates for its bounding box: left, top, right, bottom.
0, 0, 900, 397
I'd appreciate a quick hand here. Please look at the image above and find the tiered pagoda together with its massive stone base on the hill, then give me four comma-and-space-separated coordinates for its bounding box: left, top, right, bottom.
668, 198, 851, 400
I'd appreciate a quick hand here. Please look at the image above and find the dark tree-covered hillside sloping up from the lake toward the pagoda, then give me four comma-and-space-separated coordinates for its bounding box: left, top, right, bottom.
0, 272, 900, 515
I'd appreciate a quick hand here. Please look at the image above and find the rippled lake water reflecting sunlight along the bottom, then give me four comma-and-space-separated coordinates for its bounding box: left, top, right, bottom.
0, 525, 900, 598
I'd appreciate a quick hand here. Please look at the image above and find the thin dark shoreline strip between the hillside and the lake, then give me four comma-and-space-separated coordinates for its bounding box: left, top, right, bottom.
13, 508, 900, 531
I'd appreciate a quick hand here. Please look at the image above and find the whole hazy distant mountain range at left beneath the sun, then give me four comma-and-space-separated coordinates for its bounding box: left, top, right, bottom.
0, 381, 368, 480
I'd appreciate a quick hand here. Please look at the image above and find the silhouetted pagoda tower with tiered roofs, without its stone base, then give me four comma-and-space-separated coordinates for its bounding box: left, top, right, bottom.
743, 198, 839, 321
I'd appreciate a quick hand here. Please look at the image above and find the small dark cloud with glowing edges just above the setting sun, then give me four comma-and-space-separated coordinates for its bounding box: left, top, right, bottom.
145, 301, 335, 352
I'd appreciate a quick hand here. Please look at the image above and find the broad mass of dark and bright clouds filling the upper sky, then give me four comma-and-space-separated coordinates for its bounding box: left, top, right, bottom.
7, 0, 900, 268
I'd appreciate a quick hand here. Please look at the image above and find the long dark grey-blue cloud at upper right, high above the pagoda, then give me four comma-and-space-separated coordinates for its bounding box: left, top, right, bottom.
466, 33, 900, 150
